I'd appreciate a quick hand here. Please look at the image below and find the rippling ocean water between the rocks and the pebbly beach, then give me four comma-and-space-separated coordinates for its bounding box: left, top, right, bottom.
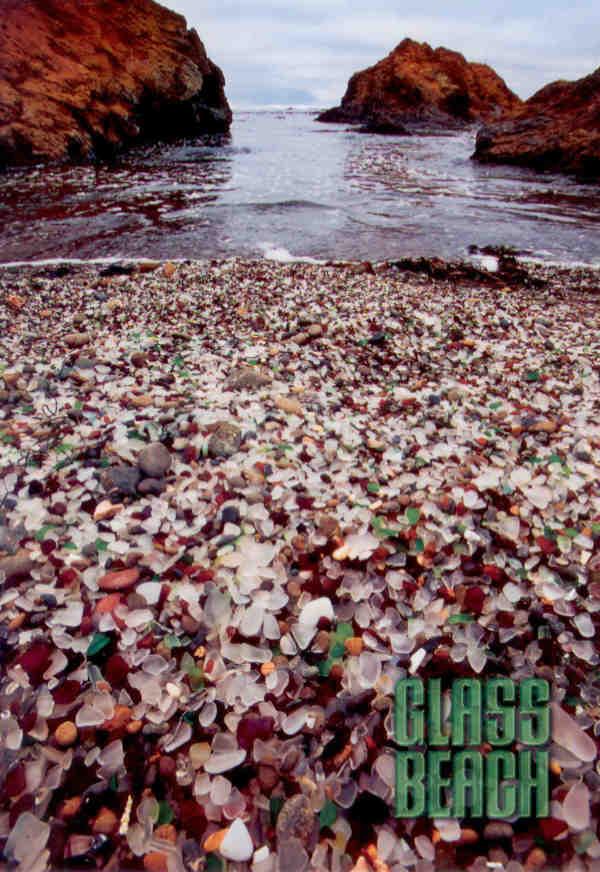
0, 110, 600, 266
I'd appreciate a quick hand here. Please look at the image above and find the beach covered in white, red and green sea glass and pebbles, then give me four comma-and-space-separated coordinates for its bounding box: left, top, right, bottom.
0, 254, 600, 872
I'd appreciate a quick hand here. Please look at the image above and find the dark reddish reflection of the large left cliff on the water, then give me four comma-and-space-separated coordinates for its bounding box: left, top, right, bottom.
0, 138, 235, 261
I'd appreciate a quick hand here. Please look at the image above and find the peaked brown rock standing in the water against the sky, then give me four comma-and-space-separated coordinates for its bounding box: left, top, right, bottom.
318, 39, 521, 133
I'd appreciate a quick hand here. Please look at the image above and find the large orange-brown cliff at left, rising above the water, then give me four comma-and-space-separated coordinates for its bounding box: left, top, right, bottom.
0, 0, 231, 165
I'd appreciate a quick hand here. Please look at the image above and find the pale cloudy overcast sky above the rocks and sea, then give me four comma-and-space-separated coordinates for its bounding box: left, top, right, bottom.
165, 0, 600, 108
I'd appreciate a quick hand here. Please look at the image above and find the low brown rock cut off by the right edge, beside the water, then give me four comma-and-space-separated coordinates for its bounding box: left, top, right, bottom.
474, 68, 600, 179
